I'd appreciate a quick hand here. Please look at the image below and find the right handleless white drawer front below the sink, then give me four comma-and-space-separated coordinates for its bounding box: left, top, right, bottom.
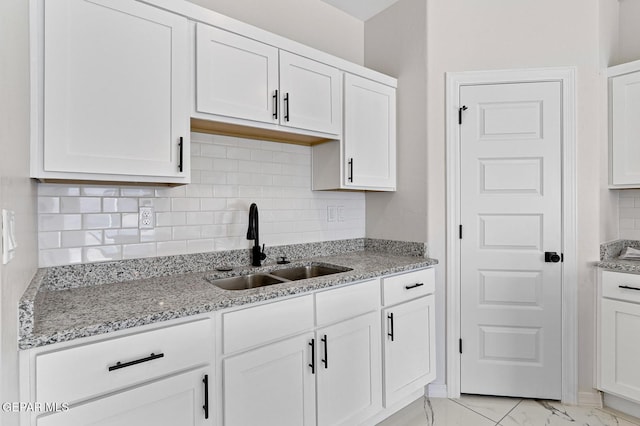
316, 279, 380, 325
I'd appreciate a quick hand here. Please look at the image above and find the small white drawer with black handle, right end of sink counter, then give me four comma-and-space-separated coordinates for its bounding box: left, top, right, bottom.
382, 268, 436, 306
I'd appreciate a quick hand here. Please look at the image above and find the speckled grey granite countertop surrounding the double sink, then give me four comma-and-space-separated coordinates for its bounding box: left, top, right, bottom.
19, 246, 438, 349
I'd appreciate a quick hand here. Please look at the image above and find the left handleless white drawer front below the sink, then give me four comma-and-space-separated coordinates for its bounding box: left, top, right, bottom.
222, 295, 313, 354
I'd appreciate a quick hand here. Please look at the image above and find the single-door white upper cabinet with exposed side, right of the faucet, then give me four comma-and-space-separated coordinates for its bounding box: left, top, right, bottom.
312, 73, 396, 191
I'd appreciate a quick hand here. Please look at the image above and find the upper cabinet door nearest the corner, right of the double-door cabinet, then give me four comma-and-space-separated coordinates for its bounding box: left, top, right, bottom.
343, 74, 396, 190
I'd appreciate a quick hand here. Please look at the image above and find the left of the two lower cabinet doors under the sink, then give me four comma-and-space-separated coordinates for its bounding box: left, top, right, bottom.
223, 333, 318, 426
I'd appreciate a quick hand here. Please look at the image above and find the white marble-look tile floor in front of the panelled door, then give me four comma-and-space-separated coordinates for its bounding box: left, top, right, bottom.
377, 395, 640, 426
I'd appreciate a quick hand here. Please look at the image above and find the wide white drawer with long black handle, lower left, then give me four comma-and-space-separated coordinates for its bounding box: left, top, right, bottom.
36, 319, 214, 403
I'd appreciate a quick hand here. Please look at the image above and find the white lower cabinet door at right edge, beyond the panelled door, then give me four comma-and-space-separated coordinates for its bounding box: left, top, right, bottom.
600, 299, 640, 402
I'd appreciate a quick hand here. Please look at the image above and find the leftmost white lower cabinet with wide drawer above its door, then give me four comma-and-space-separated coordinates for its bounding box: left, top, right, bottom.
21, 317, 216, 426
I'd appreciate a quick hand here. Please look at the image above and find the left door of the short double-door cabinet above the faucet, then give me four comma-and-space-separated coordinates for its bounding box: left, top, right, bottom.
196, 23, 278, 123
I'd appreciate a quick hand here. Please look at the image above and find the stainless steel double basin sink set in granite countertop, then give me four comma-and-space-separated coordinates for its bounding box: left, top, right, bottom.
206, 264, 351, 290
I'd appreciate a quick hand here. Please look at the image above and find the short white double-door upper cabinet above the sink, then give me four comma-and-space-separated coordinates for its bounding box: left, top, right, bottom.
195, 24, 341, 135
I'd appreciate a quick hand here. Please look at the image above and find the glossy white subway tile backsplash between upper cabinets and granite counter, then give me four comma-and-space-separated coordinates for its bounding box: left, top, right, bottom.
38, 133, 364, 266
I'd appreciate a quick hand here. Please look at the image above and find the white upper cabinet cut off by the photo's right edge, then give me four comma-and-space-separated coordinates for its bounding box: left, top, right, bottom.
609, 61, 640, 188
